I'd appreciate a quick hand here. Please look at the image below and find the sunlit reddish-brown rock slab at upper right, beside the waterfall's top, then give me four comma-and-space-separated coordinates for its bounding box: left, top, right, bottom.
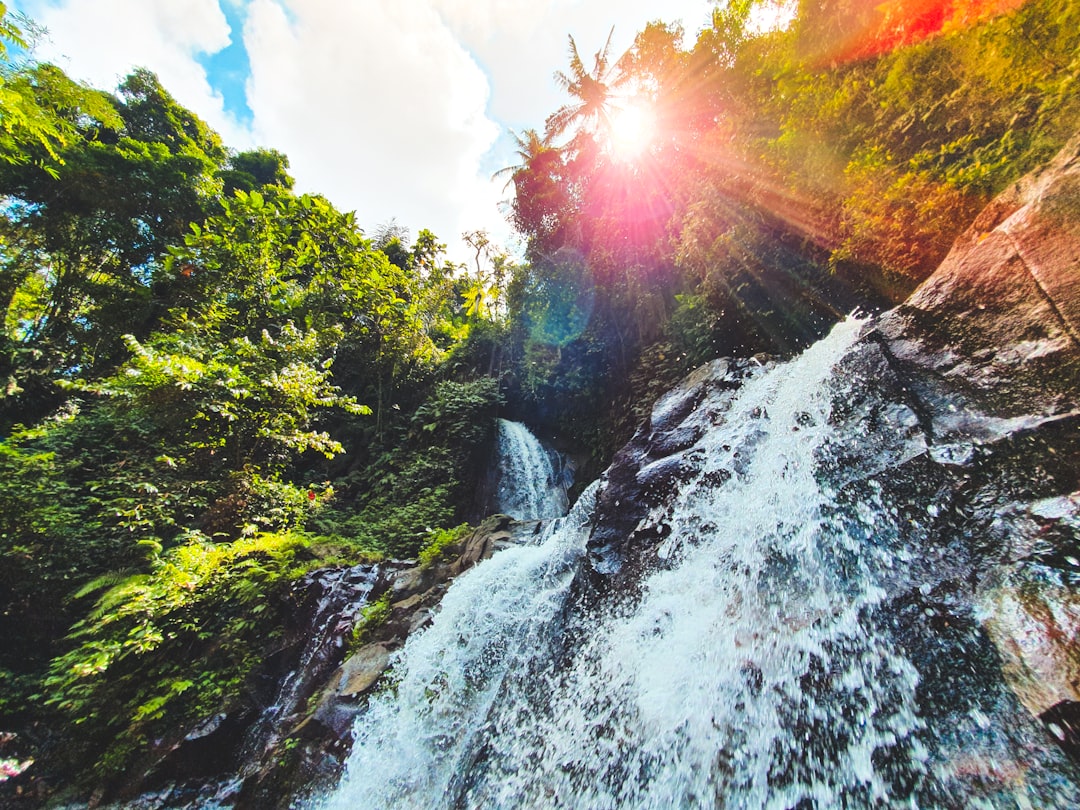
877, 139, 1080, 443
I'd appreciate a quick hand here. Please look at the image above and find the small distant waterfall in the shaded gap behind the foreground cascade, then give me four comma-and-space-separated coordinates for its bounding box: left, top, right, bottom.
495, 419, 567, 521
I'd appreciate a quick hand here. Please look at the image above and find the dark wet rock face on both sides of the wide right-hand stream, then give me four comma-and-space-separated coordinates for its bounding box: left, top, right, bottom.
591, 131, 1080, 786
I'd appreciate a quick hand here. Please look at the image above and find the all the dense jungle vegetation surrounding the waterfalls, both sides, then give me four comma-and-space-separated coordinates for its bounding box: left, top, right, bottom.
0, 0, 1080, 799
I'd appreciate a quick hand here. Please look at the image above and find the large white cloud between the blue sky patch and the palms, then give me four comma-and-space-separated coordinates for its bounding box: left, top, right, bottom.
244, 0, 499, 260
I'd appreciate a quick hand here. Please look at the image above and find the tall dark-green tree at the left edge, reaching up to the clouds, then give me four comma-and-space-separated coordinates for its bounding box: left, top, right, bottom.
0, 65, 227, 432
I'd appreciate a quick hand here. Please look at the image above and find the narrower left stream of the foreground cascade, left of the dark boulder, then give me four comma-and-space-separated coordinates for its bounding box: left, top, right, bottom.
326, 484, 597, 810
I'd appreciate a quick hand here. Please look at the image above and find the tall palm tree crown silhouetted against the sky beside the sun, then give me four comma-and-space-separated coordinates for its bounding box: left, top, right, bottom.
544, 28, 629, 143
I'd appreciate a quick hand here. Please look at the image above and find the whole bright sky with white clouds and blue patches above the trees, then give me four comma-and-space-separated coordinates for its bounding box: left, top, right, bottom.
9, 0, 713, 260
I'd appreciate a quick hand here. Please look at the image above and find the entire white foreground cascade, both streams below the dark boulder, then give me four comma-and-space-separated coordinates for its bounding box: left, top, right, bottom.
317, 321, 1077, 810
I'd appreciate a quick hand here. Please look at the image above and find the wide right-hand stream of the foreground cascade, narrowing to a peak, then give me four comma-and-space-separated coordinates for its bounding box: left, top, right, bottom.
464, 322, 926, 808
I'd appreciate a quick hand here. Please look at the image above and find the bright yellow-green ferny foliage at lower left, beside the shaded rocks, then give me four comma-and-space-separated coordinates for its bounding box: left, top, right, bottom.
43, 534, 317, 779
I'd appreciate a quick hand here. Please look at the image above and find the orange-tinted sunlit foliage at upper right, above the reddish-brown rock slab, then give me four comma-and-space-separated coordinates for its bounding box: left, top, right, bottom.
771, 0, 1080, 295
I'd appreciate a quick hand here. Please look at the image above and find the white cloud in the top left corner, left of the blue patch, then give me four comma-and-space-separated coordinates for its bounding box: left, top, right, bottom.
23, 0, 249, 147
